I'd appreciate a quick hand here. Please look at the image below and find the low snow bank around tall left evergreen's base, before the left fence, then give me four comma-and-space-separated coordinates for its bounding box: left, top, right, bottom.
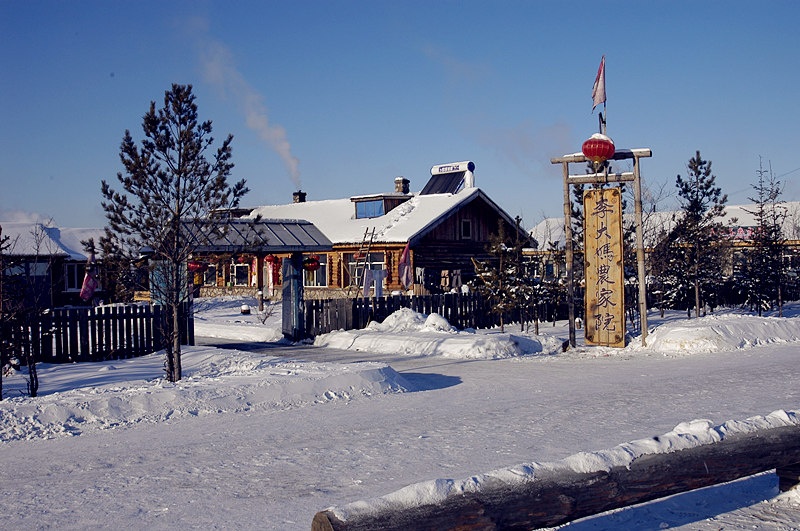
0, 347, 416, 442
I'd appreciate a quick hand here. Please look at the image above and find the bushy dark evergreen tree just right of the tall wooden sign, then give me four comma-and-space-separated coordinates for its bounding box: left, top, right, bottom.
654, 151, 728, 316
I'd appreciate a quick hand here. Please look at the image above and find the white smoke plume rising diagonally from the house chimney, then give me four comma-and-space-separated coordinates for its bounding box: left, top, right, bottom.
202, 41, 301, 190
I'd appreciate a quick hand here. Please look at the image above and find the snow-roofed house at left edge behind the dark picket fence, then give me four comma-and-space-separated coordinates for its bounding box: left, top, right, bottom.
0, 221, 104, 308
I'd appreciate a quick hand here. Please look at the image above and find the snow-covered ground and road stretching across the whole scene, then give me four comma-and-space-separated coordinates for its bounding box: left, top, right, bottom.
0, 298, 800, 530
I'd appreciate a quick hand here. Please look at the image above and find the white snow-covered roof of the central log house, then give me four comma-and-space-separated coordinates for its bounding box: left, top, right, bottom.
250, 188, 504, 245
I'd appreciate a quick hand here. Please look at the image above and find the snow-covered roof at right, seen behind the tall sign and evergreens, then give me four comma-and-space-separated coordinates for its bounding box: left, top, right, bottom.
531, 201, 800, 250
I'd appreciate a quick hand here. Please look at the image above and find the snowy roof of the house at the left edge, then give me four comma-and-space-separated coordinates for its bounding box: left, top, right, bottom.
0, 221, 104, 260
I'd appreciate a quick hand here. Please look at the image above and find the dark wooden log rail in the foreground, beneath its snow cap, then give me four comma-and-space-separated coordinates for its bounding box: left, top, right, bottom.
311, 425, 800, 531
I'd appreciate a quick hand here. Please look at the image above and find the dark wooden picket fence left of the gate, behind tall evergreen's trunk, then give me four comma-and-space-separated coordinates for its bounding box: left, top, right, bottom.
0, 304, 194, 363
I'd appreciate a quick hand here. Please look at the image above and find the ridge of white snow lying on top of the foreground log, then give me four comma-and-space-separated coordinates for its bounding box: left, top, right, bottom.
327, 410, 800, 521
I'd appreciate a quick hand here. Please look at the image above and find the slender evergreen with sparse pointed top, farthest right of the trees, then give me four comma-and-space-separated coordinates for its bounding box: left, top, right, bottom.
743, 159, 787, 315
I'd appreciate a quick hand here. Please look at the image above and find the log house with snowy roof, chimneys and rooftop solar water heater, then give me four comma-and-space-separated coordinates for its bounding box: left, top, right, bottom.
228, 162, 527, 296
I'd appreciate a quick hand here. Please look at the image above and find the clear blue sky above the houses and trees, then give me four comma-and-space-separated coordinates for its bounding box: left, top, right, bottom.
0, 0, 800, 227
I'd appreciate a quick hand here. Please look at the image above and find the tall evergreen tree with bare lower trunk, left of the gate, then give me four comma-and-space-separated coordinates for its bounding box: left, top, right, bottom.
102, 84, 248, 382
